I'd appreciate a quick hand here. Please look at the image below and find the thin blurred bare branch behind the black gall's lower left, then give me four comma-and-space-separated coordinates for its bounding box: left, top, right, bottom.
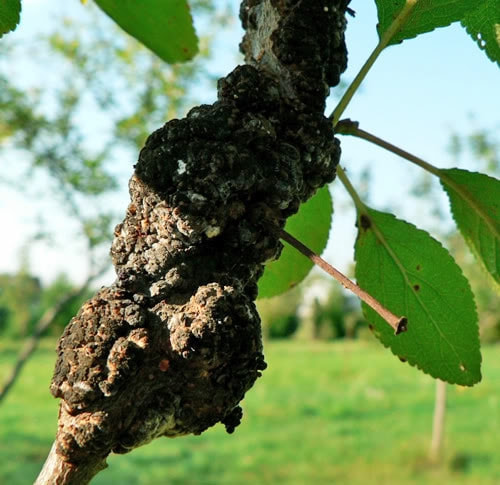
0, 271, 102, 403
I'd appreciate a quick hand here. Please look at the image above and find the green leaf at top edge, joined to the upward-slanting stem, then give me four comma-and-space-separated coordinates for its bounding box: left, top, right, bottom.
375, 0, 476, 45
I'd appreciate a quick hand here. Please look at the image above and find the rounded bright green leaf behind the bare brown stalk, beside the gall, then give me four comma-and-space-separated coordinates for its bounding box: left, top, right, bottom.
259, 187, 333, 298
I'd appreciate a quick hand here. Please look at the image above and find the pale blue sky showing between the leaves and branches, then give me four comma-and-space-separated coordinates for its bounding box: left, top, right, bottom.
0, 0, 500, 282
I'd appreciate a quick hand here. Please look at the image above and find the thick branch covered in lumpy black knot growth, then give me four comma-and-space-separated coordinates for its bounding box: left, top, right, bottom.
37, 0, 348, 485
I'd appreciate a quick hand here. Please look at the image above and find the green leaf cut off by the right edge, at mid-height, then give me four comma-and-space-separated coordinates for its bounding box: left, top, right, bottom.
439, 168, 500, 284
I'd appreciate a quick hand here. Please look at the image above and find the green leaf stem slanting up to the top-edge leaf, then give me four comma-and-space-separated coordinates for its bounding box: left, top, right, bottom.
330, 0, 418, 127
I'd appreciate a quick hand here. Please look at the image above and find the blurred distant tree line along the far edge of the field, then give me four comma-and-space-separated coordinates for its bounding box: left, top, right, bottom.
0, 246, 500, 343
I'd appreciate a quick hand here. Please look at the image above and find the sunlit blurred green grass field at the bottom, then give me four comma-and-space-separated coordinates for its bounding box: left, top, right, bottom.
0, 341, 500, 485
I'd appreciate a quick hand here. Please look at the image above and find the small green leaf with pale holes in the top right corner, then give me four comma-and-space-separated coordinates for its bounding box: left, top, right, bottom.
462, 0, 500, 66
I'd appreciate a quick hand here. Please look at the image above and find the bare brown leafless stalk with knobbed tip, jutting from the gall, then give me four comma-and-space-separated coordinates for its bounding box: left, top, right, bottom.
279, 230, 408, 335
